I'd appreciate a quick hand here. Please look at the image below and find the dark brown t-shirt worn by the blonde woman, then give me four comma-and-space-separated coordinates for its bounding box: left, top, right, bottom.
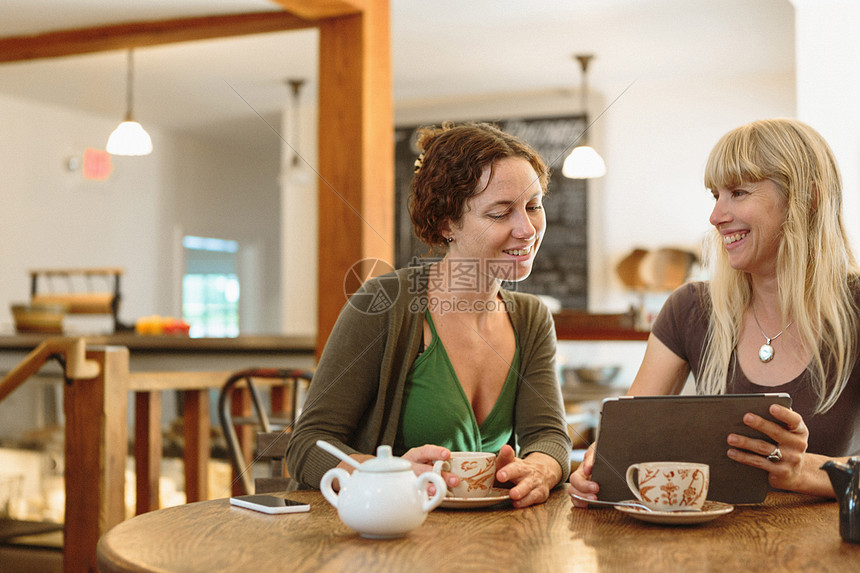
652, 282, 860, 456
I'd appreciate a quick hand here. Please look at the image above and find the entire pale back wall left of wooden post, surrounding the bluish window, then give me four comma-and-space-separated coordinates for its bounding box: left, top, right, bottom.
0, 96, 280, 332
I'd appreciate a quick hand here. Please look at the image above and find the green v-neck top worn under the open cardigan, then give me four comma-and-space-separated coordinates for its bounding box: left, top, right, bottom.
397, 312, 520, 453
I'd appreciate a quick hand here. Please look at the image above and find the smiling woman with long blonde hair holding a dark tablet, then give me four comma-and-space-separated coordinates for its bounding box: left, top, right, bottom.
569, 119, 860, 507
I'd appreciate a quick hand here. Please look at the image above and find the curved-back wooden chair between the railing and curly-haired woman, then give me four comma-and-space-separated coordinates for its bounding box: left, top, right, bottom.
218, 368, 313, 495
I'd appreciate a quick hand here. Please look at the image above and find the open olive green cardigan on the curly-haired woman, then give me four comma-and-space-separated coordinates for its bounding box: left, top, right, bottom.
286, 265, 571, 488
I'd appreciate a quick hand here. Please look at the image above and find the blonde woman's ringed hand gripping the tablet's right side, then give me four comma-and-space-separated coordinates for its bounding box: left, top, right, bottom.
727, 404, 832, 495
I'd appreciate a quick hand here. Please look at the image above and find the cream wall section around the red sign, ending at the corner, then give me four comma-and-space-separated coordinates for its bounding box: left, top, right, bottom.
0, 96, 170, 329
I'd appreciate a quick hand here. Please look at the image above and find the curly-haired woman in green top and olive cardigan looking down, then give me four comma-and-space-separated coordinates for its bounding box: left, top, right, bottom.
287, 123, 570, 507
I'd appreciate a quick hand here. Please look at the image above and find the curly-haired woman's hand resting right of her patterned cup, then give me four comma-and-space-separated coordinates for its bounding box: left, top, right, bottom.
496, 444, 561, 508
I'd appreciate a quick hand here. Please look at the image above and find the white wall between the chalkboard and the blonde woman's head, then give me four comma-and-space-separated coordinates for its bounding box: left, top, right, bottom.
590, 72, 796, 311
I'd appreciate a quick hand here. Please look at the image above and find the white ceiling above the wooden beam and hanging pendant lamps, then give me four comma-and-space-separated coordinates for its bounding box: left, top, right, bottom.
0, 0, 794, 145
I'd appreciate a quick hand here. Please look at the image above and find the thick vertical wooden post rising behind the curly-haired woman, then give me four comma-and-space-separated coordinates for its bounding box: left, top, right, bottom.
317, 0, 394, 356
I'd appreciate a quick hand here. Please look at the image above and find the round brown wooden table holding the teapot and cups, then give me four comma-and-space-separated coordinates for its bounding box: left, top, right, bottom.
98, 488, 860, 573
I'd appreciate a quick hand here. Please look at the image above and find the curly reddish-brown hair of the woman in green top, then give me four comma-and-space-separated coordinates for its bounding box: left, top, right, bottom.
409, 122, 549, 247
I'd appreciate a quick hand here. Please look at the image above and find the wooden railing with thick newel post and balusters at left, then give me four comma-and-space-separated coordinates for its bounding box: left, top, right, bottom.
0, 337, 296, 571
